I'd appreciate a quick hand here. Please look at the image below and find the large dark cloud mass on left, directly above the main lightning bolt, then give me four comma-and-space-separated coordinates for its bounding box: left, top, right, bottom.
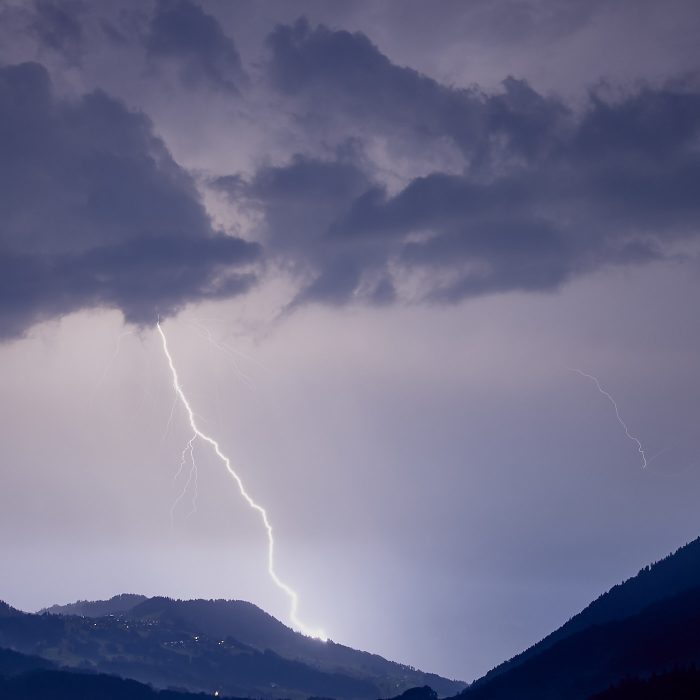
0, 63, 258, 337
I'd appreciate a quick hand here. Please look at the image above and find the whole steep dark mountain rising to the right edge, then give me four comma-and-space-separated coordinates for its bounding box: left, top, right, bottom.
459, 539, 700, 700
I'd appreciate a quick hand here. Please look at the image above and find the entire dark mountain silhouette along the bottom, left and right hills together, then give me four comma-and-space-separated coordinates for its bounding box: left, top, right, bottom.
0, 539, 700, 700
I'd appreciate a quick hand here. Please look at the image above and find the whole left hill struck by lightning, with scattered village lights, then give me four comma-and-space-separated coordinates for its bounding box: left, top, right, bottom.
0, 596, 465, 700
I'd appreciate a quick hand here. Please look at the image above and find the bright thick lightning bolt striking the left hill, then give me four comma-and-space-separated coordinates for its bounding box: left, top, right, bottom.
156, 321, 328, 642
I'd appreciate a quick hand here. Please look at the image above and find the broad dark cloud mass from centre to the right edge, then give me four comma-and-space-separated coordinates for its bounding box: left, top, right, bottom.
212, 20, 700, 304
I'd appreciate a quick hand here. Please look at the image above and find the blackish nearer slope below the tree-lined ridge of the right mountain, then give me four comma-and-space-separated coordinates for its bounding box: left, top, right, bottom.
459, 587, 700, 700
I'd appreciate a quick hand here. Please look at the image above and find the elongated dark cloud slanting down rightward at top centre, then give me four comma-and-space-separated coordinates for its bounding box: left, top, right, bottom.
267, 19, 567, 165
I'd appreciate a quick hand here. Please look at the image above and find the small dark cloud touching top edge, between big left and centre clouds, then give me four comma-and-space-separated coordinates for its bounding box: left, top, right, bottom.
146, 0, 246, 94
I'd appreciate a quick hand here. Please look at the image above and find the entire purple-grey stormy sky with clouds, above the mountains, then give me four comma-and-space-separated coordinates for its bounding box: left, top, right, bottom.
0, 0, 700, 680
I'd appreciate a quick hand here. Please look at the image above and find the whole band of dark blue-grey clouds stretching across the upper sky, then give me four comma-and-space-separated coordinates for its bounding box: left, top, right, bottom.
0, 0, 700, 337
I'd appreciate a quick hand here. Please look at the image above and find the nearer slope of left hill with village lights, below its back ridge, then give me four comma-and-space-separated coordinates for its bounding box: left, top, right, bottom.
0, 614, 380, 700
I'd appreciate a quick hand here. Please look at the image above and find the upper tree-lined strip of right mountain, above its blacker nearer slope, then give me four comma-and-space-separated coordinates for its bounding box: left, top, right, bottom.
476, 538, 700, 684
